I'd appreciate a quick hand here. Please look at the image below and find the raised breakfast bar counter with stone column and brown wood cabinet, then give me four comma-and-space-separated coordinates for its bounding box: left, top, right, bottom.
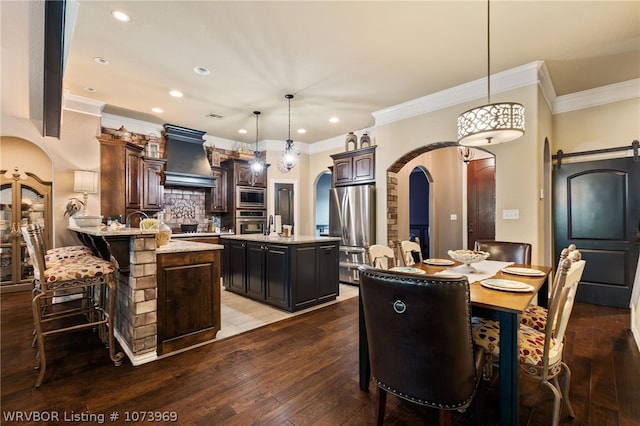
69, 227, 223, 365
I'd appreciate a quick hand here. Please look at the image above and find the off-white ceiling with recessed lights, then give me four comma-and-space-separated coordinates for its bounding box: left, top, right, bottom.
3, 0, 640, 143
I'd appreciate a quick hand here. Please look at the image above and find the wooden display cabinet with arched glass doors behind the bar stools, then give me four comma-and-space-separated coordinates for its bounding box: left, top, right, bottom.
0, 167, 52, 293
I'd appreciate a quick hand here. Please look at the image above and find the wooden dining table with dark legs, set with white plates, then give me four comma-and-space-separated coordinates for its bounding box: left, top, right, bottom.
359, 262, 552, 425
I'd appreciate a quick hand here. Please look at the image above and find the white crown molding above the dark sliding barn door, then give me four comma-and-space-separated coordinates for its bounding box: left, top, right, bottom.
552, 78, 640, 114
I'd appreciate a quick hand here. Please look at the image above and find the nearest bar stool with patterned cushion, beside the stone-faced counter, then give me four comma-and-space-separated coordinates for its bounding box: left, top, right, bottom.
25, 225, 124, 387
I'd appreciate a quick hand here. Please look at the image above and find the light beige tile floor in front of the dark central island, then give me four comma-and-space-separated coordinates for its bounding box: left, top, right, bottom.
215, 284, 358, 340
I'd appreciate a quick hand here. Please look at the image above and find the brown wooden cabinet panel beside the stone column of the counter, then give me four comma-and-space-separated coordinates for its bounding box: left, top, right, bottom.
157, 250, 221, 355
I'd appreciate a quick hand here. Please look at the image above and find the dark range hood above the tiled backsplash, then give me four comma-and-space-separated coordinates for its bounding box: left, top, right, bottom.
164, 124, 214, 188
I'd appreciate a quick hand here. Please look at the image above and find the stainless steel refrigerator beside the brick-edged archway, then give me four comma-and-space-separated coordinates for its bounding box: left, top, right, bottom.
329, 185, 376, 285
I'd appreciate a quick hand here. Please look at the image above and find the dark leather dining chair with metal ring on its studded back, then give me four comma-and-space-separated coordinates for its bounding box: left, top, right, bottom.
359, 266, 484, 425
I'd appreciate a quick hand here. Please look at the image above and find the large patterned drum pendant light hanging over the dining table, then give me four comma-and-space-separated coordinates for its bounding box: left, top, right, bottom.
458, 0, 524, 146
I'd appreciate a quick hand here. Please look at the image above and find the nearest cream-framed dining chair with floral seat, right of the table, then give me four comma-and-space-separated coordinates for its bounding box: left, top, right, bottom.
473, 258, 585, 426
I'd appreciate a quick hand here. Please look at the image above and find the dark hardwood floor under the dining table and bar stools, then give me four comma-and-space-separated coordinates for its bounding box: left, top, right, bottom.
0, 293, 640, 426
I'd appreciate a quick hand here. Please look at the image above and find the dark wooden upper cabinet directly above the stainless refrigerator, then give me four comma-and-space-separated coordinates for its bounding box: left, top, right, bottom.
331, 145, 377, 186
